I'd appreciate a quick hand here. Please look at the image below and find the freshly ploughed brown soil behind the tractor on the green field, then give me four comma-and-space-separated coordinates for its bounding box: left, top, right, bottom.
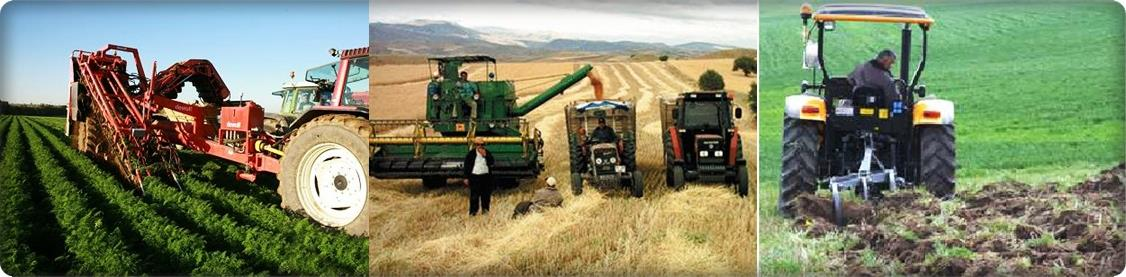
794, 163, 1126, 276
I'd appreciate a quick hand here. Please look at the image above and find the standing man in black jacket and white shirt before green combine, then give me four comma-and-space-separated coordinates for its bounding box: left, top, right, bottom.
462, 137, 497, 216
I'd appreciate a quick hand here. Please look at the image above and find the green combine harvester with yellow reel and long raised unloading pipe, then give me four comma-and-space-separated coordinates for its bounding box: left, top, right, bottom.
369, 55, 600, 188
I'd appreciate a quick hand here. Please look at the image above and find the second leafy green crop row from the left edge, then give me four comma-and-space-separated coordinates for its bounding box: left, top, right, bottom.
17, 119, 140, 275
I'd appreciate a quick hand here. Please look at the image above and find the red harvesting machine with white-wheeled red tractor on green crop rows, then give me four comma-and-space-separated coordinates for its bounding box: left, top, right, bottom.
66, 45, 372, 235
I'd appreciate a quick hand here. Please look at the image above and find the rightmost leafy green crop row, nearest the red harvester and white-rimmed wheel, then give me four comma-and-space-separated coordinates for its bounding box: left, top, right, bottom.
23, 117, 367, 275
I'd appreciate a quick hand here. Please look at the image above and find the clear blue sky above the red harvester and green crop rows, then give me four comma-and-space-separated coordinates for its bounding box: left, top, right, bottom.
0, 0, 367, 110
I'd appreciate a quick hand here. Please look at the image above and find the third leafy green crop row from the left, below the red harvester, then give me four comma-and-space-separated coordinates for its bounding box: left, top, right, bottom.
20, 117, 247, 275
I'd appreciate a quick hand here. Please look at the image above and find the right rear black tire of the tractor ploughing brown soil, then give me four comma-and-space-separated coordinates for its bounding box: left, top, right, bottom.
918, 125, 957, 199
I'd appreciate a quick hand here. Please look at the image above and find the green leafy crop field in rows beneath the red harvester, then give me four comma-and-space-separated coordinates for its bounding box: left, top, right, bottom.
0, 116, 367, 275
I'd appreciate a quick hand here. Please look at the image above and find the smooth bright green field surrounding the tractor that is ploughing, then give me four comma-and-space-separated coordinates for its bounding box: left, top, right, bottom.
759, 1, 1126, 276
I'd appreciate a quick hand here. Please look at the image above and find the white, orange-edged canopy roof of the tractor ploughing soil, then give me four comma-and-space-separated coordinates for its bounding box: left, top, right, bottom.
802, 3, 935, 27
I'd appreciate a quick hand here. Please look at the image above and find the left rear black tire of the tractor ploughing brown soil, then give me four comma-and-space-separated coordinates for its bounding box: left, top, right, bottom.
778, 118, 821, 217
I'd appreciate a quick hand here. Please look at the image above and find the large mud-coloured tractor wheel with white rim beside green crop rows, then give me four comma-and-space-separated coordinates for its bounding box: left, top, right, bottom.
278, 115, 374, 235
